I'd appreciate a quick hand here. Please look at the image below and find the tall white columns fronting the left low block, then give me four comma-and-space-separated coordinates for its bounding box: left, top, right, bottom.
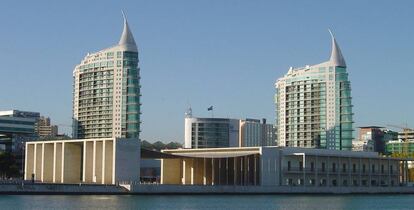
24, 140, 115, 184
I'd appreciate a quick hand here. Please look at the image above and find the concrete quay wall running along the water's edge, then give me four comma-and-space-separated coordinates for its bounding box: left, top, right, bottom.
0, 183, 414, 195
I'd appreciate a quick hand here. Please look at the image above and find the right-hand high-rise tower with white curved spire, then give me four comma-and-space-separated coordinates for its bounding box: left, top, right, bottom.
275, 30, 353, 150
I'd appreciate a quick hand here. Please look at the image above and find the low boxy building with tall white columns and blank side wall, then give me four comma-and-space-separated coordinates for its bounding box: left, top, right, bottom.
24, 138, 141, 184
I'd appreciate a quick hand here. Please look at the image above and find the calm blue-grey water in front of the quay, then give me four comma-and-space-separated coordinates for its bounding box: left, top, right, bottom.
0, 195, 414, 210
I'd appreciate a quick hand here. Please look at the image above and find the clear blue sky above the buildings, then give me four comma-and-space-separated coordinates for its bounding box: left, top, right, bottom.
0, 0, 414, 142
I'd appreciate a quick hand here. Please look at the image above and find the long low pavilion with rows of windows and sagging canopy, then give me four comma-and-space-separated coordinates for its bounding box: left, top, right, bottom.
161, 147, 409, 187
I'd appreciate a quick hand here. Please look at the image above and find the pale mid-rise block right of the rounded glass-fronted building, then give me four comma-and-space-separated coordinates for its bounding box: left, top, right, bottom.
239, 119, 276, 147
